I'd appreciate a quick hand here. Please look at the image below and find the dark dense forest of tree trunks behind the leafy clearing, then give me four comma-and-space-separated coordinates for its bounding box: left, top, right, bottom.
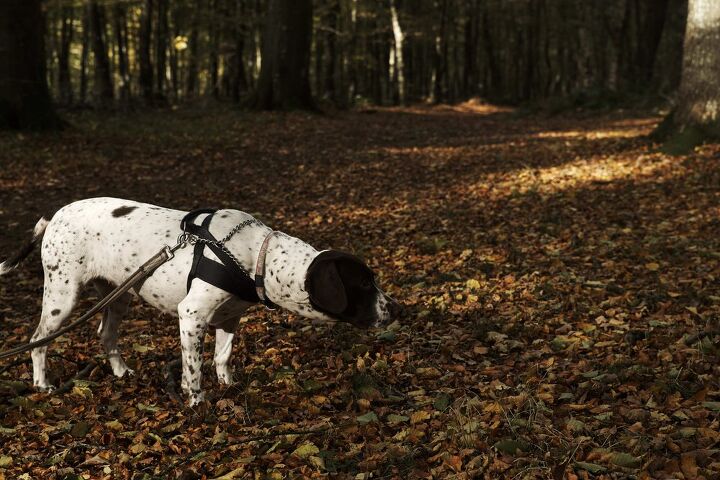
33, 0, 687, 107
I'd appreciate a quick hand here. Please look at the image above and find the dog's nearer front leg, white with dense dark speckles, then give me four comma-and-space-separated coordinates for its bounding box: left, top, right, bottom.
178, 296, 208, 407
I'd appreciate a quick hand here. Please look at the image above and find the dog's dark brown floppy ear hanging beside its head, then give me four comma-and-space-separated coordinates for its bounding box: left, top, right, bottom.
305, 251, 348, 315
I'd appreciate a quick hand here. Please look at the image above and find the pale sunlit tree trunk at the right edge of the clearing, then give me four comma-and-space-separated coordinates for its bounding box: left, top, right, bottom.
672, 0, 720, 130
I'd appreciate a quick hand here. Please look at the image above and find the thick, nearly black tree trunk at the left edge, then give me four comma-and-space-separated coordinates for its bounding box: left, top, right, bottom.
0, 0, 61, 129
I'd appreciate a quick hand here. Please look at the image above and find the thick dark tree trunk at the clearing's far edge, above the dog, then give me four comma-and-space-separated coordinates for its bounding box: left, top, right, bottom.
253, 0, 315, 110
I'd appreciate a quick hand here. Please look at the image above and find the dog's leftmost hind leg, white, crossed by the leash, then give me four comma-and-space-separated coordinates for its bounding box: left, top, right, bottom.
30, 278, 80, 391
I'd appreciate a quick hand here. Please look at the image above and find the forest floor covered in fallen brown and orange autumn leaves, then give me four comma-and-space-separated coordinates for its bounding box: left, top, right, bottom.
0, 104, 720, 479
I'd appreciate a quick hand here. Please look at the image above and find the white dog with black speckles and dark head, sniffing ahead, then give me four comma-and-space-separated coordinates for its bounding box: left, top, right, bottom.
0, 197, 401, 406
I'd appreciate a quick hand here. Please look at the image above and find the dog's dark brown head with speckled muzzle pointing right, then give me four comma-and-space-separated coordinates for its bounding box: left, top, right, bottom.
305, 250, 400, 328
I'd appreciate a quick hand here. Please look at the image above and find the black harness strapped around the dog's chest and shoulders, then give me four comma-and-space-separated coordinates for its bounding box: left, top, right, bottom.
180, 208, 277, 310
